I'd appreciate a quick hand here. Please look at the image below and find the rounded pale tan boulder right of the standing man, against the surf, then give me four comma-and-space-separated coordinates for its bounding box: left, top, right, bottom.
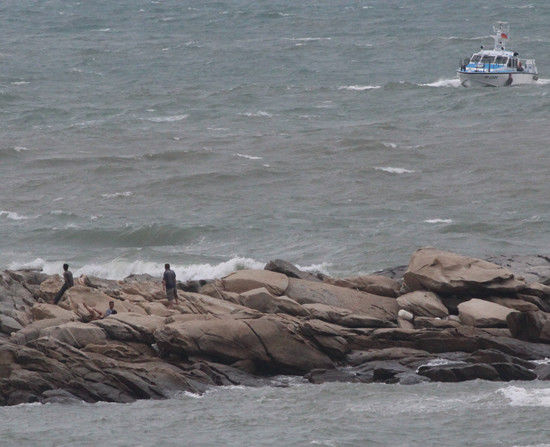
222, 270, 288, 295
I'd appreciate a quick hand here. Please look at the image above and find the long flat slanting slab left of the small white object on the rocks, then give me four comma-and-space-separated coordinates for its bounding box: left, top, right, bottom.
286, 278, 399, 321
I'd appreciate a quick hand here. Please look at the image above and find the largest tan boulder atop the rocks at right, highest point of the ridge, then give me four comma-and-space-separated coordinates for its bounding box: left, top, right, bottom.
404, 247, 526, 296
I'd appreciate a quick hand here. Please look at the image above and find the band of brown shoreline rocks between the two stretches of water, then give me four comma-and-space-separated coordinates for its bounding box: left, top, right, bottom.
0, 247, 550, 405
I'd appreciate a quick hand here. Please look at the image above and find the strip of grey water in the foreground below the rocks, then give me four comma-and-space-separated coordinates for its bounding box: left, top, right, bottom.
0, 381, 550, 447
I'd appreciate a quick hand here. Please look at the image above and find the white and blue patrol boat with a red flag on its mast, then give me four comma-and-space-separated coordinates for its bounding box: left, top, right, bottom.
457, 22, 539, 87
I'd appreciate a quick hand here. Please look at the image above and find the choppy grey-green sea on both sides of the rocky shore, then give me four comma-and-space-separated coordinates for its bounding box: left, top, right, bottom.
0, 0, 550, 446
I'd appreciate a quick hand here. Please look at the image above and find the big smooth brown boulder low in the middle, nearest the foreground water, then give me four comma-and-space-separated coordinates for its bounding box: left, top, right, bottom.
155, 316, 333, 373
